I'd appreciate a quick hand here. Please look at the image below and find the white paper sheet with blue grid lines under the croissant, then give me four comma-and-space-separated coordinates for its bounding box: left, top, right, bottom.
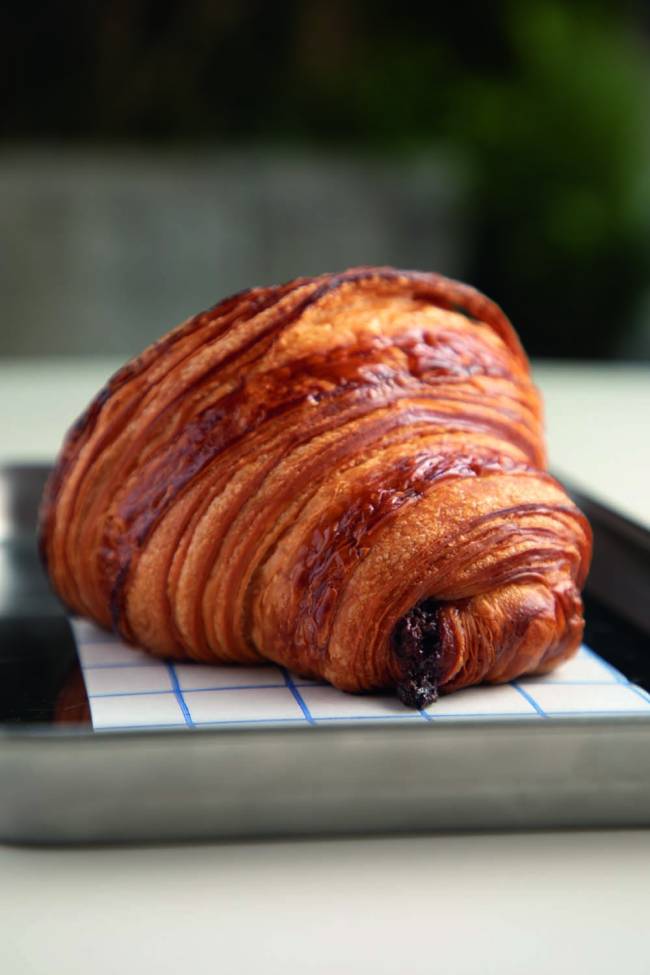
72, 620, 650, 731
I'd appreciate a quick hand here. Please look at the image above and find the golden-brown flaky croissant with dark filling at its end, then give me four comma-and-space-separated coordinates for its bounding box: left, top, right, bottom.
41, 267, 591, 708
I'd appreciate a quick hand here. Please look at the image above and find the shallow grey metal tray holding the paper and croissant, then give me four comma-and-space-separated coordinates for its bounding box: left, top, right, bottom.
0, 466, 650, 843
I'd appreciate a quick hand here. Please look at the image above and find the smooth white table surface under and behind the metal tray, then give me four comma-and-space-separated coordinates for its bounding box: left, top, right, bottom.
0, 360, 650, 975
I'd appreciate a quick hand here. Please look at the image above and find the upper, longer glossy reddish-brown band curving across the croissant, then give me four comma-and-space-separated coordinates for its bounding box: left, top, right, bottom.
104, 336, 538, 624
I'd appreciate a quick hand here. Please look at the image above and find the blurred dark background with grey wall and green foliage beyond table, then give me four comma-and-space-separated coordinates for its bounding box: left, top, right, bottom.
0, 0, 650, 359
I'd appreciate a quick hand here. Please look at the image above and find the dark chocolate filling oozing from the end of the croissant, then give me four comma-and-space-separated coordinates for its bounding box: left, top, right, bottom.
392, 599, 440, 708
